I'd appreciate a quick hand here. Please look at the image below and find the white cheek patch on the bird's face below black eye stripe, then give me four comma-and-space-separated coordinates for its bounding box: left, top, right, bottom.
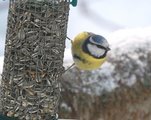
88, 44, 105, 57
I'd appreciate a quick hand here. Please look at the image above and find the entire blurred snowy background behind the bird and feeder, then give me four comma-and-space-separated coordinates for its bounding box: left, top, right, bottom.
0, 0, 151, 120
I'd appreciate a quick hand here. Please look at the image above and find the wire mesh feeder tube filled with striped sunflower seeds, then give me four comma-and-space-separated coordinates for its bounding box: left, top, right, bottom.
1, 0, 70, 120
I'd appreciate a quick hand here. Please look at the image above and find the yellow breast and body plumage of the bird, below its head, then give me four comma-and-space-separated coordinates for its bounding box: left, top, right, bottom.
72, 32, 106, 70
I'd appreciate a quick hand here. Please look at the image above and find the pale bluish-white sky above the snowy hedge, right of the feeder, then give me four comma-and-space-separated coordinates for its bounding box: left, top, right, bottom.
68, 0, 151, 44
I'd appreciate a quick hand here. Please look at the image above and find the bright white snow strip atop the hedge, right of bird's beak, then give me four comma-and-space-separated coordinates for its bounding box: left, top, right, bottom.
107, 27, 151, 50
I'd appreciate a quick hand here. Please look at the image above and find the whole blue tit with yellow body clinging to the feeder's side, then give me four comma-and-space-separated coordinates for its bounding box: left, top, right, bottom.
72, 32, 110, 70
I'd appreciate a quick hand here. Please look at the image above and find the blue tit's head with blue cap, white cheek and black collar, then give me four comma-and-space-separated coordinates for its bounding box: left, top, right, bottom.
82, 34, 110, 58
